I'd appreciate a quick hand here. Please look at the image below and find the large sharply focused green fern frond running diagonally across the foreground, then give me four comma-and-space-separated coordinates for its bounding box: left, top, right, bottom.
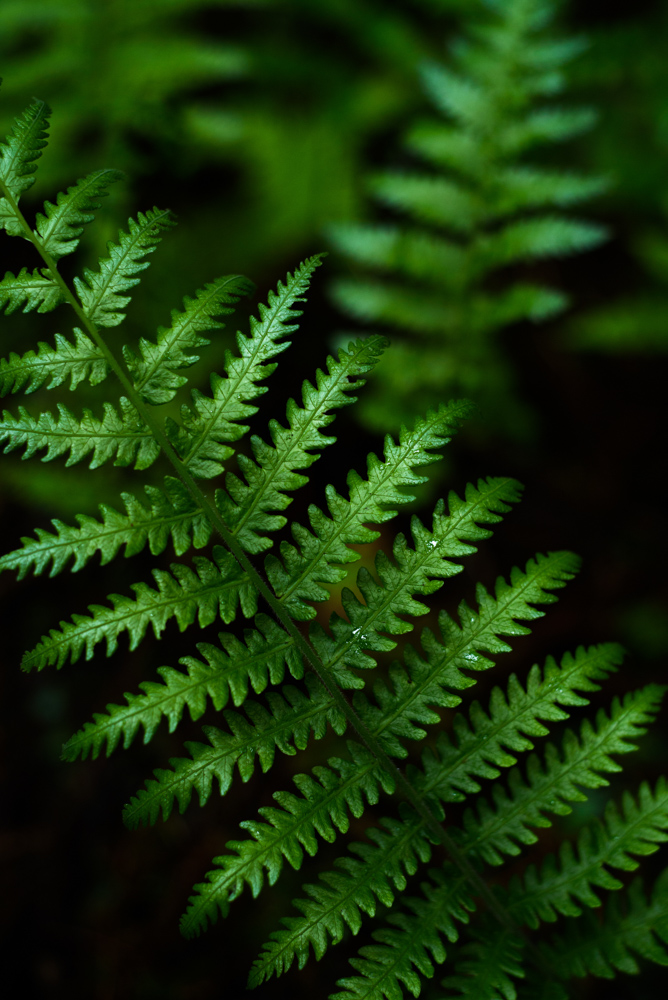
0, 90, 668, 1000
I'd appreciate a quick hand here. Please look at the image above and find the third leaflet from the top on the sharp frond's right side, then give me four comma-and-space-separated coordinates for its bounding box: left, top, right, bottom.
74, 208, 174, 326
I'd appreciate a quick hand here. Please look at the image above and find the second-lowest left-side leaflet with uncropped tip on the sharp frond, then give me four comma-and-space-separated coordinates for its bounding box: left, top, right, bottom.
181, 743, 395, 937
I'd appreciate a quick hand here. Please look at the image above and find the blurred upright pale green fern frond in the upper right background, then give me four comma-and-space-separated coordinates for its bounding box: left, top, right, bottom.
330, 0, 605, 433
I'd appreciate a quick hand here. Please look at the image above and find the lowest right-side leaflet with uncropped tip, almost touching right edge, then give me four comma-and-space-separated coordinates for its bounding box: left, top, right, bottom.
462, 685, 665, 865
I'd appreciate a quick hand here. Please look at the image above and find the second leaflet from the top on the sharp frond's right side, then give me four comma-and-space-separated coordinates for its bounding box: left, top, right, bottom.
36, 169, 123, 260
